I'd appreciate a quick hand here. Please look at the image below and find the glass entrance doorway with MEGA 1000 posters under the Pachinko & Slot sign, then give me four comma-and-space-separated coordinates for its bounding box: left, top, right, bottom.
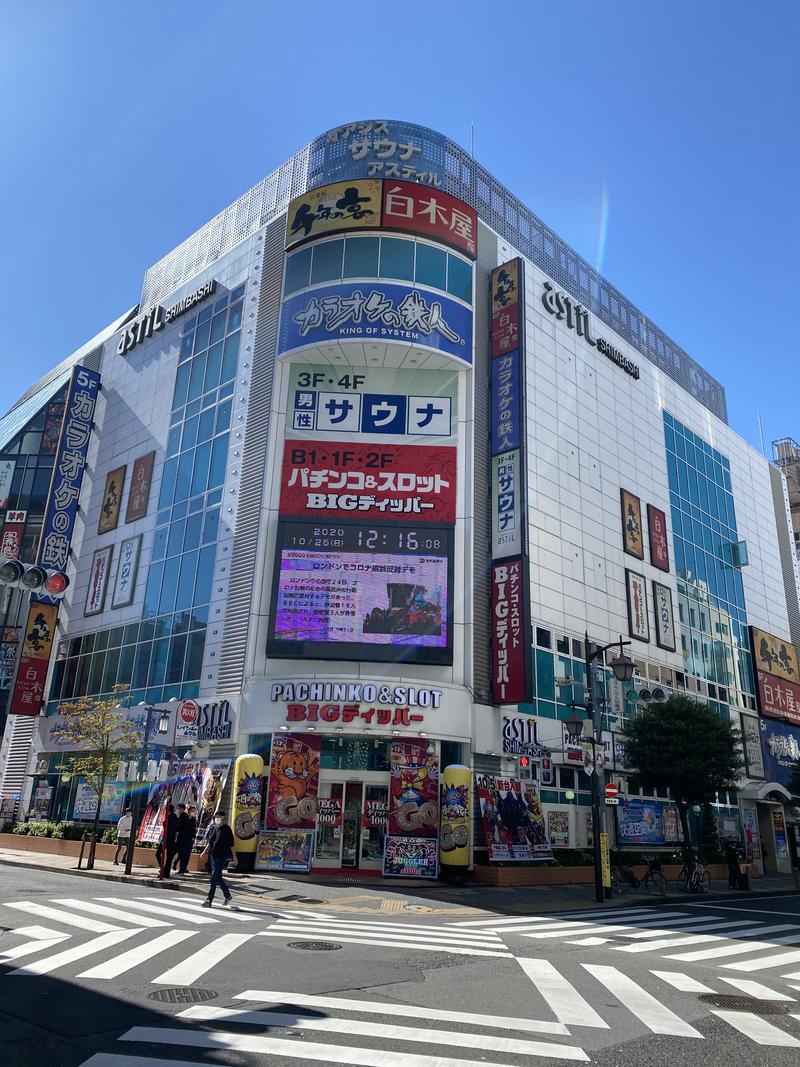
314, 775, 388, 871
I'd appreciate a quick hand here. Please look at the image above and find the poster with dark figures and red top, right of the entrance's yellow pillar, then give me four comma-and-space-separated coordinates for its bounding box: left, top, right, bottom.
475, 775, 553, 863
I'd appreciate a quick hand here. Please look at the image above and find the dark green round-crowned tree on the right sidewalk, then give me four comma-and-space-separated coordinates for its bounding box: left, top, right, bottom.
624, 697, 743, 857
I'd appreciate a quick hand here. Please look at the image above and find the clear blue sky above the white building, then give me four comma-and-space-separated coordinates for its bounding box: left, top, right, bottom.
0, 0, 800, 451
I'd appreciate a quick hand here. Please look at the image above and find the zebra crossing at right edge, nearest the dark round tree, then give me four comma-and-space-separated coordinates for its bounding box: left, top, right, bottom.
452, 908, 800, 978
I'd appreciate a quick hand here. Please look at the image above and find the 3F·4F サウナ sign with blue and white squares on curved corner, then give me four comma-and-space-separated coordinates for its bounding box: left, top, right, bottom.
287, 363, 459, 444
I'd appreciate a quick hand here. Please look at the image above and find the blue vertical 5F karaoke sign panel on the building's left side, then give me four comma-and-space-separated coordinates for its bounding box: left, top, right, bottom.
38, 366, 100, 571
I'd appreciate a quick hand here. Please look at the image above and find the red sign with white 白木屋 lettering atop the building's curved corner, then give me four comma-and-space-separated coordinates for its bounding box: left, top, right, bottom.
383, 181, 478, 259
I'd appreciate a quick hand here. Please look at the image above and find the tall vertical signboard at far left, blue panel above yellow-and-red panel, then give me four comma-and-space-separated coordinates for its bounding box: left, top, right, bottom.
9, 366, 100, 715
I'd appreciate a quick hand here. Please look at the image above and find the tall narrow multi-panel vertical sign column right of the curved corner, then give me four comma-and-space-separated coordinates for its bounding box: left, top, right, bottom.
490, 258, 530, 704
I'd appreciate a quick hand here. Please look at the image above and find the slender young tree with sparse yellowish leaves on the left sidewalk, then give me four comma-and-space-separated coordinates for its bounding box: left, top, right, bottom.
52, 685, 141, 870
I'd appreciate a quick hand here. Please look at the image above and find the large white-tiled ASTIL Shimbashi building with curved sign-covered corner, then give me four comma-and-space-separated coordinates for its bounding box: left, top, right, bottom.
0, 121, 800, 872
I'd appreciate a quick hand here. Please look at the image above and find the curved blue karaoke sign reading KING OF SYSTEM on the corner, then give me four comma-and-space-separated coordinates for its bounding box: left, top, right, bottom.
277, 280, 473, 364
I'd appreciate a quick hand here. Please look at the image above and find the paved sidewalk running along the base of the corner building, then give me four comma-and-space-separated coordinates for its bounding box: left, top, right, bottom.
0, 848, 800, 918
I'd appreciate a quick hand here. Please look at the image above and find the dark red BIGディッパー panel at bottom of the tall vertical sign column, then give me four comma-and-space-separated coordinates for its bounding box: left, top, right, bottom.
492, 559, 528, 704
